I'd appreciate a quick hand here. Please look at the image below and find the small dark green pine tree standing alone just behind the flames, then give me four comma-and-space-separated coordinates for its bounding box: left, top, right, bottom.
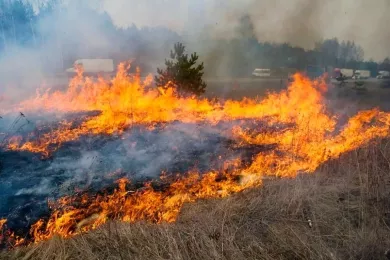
155, 42, 207, 95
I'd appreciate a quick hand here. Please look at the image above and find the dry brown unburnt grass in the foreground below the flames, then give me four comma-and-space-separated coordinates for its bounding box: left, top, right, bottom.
0, 142, 390, 260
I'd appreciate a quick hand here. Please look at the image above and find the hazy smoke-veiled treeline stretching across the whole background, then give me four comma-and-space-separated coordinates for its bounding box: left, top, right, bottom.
0, 0, 390, 76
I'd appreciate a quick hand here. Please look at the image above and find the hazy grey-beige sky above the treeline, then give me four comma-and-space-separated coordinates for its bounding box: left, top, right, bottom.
88, 0, 390, 60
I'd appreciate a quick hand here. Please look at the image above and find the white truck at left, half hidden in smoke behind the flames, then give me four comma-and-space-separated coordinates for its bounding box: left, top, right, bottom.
66, 59, 114, 76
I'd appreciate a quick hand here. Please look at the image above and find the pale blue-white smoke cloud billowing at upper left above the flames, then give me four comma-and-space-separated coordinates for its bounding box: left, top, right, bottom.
0, 1, 175, 102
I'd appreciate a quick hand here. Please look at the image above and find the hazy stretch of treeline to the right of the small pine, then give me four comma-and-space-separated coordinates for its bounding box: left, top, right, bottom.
205, 16, 390, 76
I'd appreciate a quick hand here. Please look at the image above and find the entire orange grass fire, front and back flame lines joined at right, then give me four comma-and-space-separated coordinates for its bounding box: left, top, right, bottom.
0, 64, 390, 248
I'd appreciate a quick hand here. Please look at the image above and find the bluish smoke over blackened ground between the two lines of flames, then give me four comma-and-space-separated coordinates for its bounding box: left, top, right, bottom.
0, 119, 248, 227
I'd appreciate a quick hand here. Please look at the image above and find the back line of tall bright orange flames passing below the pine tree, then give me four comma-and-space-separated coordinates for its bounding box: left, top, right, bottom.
3, 64, 332, 155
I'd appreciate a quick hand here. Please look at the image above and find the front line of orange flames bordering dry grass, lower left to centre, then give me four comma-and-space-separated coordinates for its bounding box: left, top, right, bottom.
30, 172, 261, 242
